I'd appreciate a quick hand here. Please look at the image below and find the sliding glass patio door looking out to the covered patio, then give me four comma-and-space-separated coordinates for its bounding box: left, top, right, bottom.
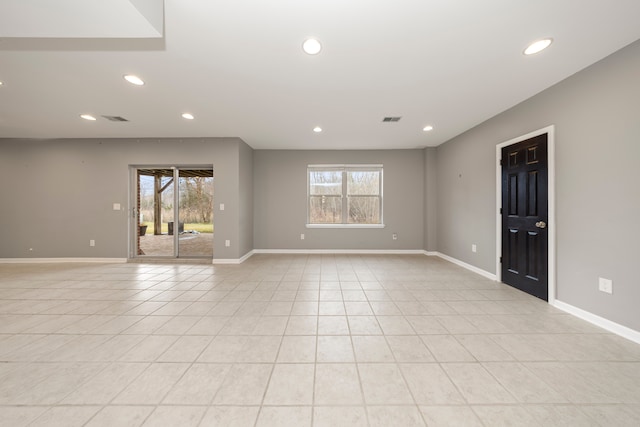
131, 166, 214, 258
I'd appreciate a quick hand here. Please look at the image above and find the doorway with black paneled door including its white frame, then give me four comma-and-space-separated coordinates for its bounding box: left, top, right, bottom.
496, 126, 556, 304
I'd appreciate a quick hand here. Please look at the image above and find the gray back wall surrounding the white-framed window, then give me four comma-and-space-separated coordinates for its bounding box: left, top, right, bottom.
254, 150, 425, 250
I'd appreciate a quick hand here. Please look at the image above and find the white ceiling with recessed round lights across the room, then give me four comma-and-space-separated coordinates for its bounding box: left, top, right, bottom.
0, 0, 640, 149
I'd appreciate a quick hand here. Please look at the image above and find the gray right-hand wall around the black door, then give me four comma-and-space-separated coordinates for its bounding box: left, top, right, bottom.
437, 42, 640, 330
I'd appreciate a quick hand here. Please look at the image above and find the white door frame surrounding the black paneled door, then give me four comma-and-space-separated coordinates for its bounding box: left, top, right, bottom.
496, 125, 556, 305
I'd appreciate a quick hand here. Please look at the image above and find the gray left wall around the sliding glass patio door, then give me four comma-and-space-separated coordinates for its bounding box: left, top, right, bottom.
0, 138, 251, 259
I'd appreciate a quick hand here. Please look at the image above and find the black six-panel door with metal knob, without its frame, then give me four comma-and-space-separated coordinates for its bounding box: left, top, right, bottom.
501, 134, 549, 301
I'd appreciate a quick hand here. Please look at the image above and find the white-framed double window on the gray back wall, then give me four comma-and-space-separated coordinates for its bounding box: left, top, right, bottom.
307, 165, 382, 227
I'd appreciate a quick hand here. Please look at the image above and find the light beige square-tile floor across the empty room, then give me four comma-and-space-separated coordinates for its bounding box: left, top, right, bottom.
0, 255, 640, 427
